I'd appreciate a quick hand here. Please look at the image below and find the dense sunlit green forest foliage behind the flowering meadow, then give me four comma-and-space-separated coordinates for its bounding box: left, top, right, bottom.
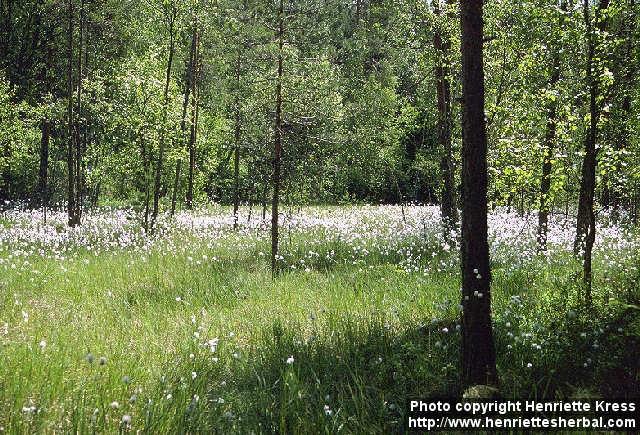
0, 0, 640, 212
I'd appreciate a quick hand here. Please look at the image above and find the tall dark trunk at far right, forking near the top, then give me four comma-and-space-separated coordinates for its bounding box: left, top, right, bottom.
573, 0, 609, 304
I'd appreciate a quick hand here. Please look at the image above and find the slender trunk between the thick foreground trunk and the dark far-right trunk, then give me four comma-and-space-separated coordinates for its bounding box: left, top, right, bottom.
538, 49, 560, 251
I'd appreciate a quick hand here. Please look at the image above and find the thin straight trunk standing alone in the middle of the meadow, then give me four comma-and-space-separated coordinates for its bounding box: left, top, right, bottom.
271, 0, 284, 275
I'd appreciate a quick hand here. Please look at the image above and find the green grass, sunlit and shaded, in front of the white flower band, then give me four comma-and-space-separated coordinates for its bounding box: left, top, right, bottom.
0, 207, 640, 433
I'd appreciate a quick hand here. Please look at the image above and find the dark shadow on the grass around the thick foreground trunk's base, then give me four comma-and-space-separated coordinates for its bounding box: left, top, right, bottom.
152, 282, 640, 433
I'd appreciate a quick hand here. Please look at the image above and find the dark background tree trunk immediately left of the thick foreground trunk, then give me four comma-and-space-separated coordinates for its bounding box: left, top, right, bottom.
433, 0, 458, 241
